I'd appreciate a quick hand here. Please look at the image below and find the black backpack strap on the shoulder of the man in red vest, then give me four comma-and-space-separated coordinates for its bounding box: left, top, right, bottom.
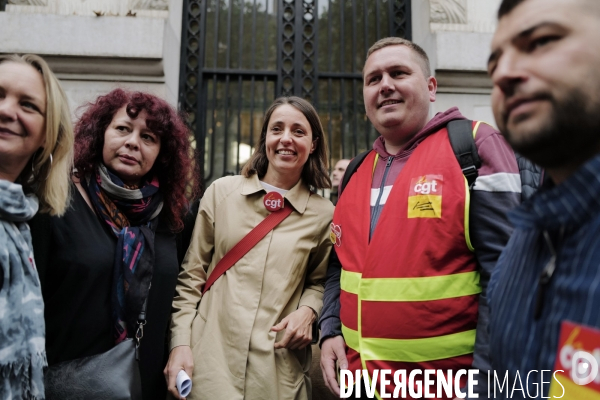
446, 119, 481, 188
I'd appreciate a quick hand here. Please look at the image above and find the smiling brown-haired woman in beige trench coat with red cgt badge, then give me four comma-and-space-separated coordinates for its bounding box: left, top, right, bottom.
165, 97, 333, 400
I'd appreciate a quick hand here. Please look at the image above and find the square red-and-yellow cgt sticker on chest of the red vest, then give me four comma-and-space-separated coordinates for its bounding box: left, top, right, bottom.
408, 175, 444, 218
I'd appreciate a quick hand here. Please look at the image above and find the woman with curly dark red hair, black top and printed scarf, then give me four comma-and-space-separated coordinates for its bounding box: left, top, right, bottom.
31, 89, 199, 399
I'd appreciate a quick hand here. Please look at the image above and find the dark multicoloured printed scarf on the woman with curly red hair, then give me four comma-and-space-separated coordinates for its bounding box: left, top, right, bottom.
81, 165, 163, 344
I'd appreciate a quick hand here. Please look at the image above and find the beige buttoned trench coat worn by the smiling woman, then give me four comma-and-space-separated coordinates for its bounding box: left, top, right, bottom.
171, 175, 333, 400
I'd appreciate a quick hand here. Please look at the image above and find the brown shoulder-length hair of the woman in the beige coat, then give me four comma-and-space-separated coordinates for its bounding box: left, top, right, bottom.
242, 96, 331, 189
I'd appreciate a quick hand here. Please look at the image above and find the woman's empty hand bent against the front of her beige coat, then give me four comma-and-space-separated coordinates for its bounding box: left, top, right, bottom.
271, 306, 316, 350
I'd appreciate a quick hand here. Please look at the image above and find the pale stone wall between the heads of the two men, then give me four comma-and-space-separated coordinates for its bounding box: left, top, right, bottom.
412, 0, 500, 125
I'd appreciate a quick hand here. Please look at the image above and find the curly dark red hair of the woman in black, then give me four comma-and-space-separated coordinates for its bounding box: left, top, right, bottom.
75, 89, 200, 231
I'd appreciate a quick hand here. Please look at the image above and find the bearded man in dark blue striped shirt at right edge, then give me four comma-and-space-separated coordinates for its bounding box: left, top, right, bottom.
480, 0, 600, 399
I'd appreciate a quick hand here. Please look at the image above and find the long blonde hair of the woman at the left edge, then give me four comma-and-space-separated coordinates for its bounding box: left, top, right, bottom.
0, 54, 73, 215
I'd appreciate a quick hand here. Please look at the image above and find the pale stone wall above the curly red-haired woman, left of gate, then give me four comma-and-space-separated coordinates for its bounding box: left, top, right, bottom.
0, 0, 181, 115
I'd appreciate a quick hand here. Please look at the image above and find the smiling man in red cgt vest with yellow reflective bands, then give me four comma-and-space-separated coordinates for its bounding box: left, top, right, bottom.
320, 37, 521, 398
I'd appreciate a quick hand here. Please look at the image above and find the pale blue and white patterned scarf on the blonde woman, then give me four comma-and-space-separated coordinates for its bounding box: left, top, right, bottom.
0, 180, 47, 399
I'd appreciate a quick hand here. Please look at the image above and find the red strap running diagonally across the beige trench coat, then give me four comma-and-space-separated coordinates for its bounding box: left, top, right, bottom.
202, 202, 293, 295
